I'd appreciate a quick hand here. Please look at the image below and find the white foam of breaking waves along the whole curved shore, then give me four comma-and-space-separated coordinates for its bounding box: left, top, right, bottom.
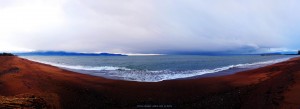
22, 58, 289, 82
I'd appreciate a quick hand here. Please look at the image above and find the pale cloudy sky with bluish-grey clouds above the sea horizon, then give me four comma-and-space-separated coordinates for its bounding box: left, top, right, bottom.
0, 0, 300, 54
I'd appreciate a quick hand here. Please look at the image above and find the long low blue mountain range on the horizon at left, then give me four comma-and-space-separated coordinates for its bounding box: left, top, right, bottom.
14, 51, 127, 56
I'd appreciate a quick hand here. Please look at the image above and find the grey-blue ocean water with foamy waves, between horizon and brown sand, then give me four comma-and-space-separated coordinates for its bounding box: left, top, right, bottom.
22, 55, 295, 82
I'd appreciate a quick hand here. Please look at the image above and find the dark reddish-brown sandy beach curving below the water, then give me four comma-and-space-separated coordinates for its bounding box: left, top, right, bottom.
0, 56, 300, 109
